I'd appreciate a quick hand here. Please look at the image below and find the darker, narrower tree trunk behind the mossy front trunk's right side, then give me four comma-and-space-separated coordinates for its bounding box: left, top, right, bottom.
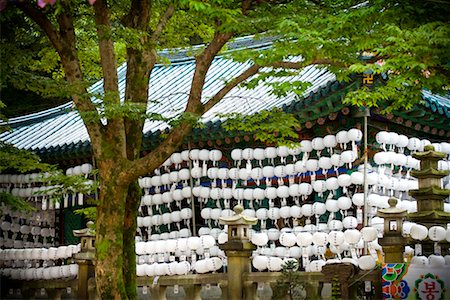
122, 182, 141, 299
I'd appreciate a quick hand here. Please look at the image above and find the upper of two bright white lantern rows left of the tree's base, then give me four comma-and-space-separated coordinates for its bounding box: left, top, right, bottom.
0, 244, 81, 261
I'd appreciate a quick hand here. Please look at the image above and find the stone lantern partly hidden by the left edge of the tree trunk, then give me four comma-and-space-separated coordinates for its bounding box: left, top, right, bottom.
73, 221, 95, 299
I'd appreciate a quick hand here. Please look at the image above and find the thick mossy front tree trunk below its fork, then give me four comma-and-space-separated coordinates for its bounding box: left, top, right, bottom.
95, 172, 128, 299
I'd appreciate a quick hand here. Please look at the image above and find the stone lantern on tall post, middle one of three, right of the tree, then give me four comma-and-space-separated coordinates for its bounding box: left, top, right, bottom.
219, 205, 258, 300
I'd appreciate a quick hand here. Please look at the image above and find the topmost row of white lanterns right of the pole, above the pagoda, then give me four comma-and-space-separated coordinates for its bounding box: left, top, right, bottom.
375, 131, 450, 154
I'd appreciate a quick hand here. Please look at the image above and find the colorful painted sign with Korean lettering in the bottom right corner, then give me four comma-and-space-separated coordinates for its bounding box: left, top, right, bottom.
381, 263, 450, 300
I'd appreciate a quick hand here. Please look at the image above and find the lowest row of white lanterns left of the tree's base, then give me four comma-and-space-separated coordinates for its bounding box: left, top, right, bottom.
0, 264, 78, 280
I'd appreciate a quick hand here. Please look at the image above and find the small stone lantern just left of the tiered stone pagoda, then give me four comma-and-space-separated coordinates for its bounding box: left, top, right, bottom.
377, 198, 407, 263
